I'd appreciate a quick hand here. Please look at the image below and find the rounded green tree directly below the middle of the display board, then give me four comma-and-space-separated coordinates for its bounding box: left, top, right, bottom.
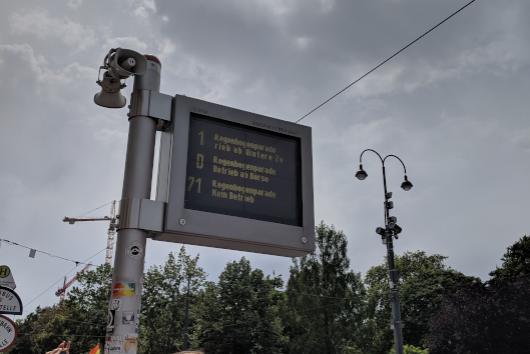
193, 257, 284, 354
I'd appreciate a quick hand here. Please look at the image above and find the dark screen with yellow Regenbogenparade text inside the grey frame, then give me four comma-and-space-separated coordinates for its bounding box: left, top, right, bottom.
184, 113, 303, 226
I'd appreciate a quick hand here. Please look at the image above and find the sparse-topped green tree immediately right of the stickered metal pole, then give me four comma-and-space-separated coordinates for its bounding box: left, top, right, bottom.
139, 247, 206, 354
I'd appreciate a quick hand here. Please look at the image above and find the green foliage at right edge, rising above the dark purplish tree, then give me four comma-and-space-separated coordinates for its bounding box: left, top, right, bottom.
489, 235, 530, 279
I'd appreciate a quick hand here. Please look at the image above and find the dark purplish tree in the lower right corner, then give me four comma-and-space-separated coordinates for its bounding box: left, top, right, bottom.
429, 278, 530, 354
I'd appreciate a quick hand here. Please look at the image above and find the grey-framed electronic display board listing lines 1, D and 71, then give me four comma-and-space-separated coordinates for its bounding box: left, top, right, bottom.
153, 95, 315, 257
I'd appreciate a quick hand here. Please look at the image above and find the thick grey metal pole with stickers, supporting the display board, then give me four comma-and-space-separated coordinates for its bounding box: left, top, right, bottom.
105, 55, 161, 353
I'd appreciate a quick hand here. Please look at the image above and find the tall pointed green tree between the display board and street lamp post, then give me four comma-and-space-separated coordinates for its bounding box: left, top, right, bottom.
280, 222, 366, 354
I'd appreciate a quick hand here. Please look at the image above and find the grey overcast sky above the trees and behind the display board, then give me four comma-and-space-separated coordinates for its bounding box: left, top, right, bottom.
0, 0, 530, 314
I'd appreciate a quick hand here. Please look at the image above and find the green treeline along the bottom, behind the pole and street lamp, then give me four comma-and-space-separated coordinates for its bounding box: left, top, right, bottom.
11, 223, 500, 354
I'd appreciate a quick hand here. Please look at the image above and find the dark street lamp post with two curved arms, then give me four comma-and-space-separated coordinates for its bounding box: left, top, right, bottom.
355, 149, 412, 354
